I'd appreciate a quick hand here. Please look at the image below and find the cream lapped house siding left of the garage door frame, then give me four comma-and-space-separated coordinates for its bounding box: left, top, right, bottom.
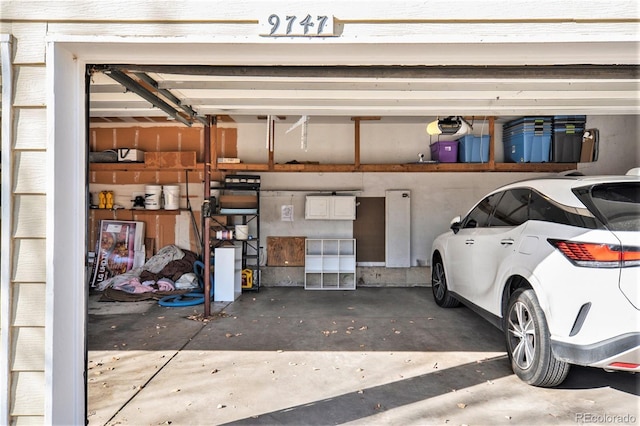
0, 17, 47, 424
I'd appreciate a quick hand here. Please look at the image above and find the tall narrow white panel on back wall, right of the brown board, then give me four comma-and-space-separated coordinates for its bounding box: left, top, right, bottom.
385, 189, 411, 268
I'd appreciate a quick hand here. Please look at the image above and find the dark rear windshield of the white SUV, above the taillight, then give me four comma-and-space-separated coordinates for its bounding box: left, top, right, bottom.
574, 182, 640, 231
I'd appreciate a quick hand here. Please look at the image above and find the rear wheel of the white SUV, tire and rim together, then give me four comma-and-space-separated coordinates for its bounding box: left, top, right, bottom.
505, 289, 570, 387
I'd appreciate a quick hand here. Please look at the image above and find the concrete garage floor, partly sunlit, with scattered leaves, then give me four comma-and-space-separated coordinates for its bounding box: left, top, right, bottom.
87, 287, 640, 425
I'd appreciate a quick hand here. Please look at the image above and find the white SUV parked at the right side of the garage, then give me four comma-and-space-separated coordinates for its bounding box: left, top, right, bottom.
432, 172, 640, 387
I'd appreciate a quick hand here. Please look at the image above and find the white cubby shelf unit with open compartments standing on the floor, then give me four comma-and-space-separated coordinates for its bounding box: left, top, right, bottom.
304, 238, 356, 290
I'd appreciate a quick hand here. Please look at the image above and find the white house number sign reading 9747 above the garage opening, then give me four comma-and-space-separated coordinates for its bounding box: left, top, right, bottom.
260, 13, 334, 37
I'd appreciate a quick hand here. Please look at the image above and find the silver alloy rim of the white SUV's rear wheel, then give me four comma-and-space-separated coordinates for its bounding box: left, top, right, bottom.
509, 301, 536, 370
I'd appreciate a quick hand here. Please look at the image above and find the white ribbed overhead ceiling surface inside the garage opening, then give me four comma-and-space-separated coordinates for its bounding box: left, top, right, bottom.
90, 66, 640, 123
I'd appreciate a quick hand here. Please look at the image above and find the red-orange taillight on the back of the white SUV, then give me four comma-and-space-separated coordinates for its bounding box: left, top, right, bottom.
547, 239, 640, 268
